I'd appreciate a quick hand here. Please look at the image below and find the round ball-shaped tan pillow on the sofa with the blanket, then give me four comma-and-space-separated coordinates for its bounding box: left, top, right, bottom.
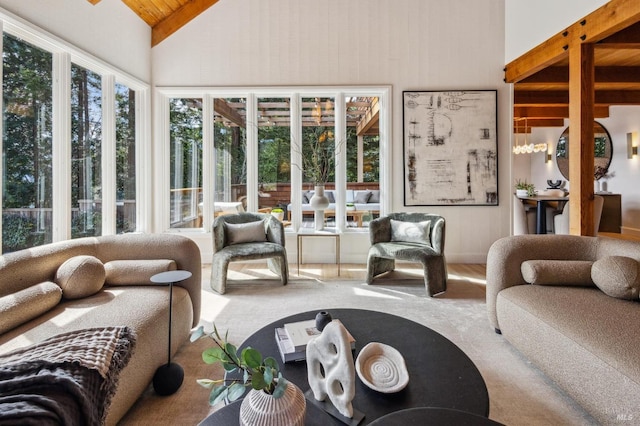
55, 256, 105, 299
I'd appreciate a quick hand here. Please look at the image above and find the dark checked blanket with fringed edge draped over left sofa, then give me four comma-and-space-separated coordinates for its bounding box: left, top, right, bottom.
0, 327, 136, 425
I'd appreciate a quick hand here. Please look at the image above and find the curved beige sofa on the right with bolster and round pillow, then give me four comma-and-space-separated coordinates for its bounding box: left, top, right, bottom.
487, 235, 640, 424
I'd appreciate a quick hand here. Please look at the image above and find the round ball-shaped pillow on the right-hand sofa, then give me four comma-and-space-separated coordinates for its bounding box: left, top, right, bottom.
591, 256, 640, 300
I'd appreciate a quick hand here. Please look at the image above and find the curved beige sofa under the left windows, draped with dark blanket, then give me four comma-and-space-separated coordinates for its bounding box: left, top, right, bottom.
0, 234, 201, 424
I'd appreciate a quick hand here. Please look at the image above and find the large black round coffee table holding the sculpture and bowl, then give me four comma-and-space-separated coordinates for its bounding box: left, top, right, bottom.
203, 309, 489, 425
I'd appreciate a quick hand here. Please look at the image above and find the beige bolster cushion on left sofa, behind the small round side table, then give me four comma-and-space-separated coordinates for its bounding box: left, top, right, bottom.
104, 259, 177, 285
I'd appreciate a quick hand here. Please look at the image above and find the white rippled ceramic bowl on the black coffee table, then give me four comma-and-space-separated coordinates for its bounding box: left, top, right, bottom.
356, 342, 409, 393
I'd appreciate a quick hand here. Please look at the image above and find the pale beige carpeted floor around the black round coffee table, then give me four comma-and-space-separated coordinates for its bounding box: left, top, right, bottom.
121, 264, 596, 426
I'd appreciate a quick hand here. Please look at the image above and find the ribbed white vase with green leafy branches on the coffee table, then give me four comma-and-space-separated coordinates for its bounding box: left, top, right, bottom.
191, 324, 306, 426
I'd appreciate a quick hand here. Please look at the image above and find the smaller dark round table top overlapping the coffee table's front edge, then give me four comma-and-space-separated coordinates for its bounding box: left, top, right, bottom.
368, 407, 502, 426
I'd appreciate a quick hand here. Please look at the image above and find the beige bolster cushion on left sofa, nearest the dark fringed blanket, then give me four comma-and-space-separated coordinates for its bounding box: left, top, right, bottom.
0, 281, 62, 334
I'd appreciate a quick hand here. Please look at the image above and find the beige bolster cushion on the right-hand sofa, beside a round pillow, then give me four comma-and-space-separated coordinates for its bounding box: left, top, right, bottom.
520, 260, 594, 286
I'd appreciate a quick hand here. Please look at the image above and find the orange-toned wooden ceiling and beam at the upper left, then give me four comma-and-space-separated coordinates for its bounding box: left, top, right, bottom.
87, 0, 218, 46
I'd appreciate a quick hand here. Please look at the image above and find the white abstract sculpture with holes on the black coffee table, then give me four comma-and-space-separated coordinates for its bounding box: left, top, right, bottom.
307, 321, 356, 418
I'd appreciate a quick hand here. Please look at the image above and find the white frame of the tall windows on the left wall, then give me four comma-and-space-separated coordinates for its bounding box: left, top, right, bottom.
0, 10, 153, 250
